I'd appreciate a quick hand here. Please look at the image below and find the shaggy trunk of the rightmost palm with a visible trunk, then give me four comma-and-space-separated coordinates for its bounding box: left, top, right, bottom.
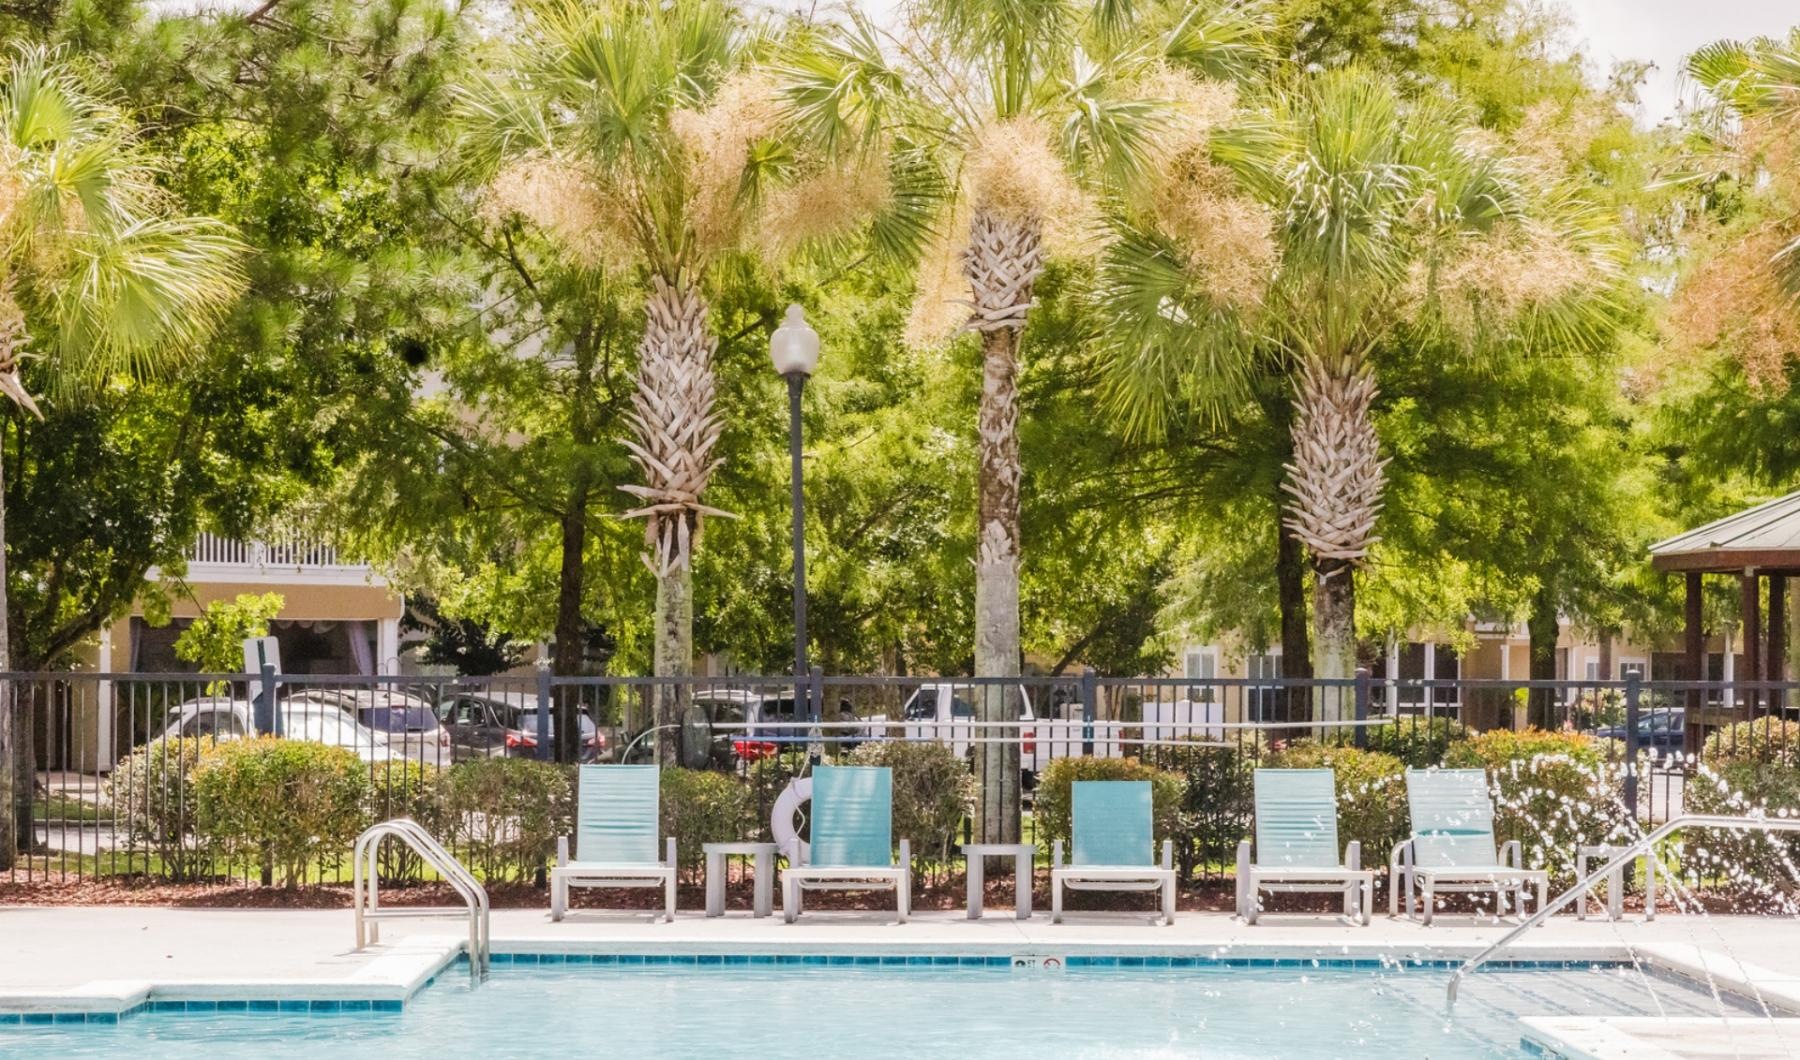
1282, 356, 1386, 720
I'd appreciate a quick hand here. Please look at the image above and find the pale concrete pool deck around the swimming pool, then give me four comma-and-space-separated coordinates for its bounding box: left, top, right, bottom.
10, 907, 1800, 1056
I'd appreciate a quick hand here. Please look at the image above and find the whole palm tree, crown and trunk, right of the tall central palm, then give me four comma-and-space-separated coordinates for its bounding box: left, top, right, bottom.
1100, 70, 1620, 709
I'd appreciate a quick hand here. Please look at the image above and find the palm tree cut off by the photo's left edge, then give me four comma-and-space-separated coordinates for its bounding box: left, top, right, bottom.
0, 47, 243, 869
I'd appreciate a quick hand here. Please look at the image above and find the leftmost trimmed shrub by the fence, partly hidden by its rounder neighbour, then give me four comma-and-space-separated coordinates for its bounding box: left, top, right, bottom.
106, 736, 205, 880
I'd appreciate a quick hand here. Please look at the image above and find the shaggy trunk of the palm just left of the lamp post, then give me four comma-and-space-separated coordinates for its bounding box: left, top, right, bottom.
621, 275, 729, 765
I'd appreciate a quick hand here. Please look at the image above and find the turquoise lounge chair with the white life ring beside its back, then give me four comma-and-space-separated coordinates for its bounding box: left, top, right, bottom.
781, 765, 913, 923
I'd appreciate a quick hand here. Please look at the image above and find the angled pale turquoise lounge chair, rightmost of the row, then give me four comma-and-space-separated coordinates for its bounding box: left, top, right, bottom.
1388, 768, 1550, 923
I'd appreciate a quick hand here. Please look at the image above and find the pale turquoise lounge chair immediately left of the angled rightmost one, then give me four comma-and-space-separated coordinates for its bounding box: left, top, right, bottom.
1237, 768, 1375, 925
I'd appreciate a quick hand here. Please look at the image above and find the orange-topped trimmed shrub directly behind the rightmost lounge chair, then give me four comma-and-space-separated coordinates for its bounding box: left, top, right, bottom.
1444, 729, 1629, 885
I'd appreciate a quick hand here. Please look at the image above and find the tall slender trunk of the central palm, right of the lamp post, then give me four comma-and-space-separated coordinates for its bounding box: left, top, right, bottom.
963, 209, 1044, 842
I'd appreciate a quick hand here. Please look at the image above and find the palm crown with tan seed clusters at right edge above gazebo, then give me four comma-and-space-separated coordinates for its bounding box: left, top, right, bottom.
1672, 29, 1800, 391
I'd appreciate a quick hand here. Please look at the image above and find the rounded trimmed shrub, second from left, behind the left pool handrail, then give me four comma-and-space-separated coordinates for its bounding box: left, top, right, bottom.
194, 736, 369, 887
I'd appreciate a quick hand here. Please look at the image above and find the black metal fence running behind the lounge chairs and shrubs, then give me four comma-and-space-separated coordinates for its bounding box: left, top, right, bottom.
0, 671, 1800, 882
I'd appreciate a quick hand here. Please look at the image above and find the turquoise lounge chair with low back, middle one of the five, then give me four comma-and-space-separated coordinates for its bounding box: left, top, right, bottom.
1049, 781, 1175, 925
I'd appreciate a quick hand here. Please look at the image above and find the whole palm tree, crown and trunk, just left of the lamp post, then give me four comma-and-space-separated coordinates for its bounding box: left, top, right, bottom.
464, 0, 887, 752
